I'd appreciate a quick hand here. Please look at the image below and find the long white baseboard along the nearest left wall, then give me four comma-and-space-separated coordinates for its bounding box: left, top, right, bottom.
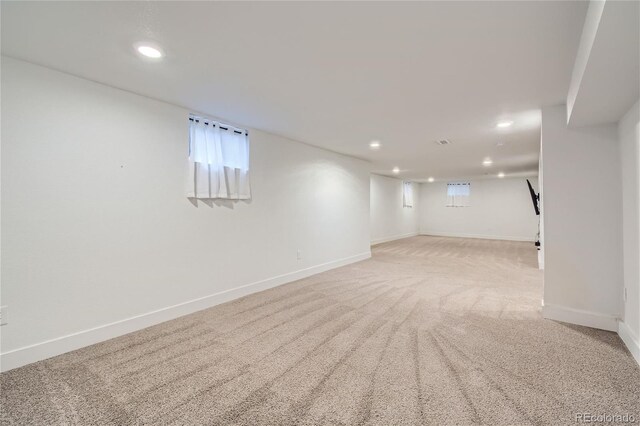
0, 252, 371, 371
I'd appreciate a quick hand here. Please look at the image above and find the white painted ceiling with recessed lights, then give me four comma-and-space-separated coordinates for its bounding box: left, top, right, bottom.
1, 1, 587, 179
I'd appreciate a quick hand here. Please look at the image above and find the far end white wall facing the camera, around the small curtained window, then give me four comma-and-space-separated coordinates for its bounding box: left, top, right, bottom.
419, 177, 538, 241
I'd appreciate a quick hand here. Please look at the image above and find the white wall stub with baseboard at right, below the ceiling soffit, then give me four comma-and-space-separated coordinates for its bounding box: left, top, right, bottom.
541, 105, 622, 330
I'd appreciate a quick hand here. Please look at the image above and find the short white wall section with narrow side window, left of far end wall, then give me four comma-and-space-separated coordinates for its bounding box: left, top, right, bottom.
370, 174, 420, 244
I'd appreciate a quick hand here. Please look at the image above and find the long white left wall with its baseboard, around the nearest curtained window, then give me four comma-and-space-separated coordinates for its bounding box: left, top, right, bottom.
1, 57, 370, 370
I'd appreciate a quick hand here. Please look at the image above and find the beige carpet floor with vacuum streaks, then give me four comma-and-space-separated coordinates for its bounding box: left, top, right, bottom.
0, 237, 640, 425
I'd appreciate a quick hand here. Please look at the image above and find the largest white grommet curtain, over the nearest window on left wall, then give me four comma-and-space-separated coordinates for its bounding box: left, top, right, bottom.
187, 118, 251, 200
